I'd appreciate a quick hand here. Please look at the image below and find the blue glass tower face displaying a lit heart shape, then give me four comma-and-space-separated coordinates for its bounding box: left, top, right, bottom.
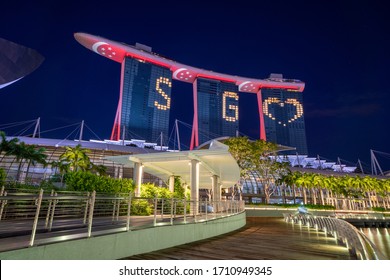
262, 75, 308, 155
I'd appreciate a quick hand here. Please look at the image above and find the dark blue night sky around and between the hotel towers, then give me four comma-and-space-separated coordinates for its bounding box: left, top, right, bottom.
0, 0, 390, 168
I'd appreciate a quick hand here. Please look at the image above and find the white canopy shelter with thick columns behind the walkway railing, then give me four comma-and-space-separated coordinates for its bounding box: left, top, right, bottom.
106, 141, 240, 212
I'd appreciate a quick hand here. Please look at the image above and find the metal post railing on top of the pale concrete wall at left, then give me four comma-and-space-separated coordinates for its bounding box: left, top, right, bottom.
0, 190, 245, 251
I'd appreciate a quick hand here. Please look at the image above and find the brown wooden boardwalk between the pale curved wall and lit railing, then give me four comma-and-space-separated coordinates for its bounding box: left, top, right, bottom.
125, 217, 354, 260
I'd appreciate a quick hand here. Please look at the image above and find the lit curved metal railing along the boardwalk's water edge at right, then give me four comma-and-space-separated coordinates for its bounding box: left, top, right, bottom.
283, 214, 383, 260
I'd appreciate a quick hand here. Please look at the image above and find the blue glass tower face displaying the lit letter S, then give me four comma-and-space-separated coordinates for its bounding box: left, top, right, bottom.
111, 57, 172, 145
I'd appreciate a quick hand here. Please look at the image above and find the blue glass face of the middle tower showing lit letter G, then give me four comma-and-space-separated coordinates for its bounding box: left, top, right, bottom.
197, 78, 239, 144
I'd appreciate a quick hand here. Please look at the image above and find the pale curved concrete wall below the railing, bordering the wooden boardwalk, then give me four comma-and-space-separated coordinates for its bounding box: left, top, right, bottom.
0, 212, 246, 260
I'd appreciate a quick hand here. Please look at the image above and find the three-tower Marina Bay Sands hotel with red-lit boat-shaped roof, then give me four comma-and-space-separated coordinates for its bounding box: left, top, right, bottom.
74, 33, 307, 154
